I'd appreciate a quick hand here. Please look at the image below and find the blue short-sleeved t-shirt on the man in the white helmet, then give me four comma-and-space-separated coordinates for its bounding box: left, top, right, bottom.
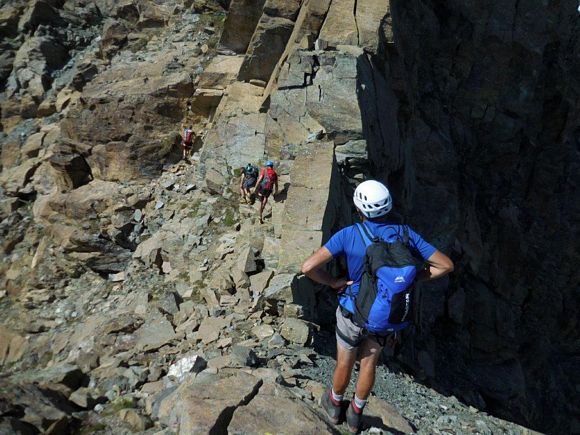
324, 221, 437, 308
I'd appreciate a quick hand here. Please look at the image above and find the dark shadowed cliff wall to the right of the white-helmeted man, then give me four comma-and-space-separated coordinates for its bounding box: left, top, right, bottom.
358, 0, 580, 431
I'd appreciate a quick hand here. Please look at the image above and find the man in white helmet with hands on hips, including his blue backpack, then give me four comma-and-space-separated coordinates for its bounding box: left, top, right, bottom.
302, 180, 454, 433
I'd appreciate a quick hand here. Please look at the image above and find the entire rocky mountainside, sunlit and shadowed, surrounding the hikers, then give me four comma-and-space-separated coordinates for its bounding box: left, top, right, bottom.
0, 0, 580, 434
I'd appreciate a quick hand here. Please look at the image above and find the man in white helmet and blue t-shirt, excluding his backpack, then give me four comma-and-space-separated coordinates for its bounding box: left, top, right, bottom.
302, 180, 454, 433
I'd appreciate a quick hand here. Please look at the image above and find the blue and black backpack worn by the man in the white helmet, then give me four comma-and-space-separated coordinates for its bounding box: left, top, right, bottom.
352, 223, 422, 334
